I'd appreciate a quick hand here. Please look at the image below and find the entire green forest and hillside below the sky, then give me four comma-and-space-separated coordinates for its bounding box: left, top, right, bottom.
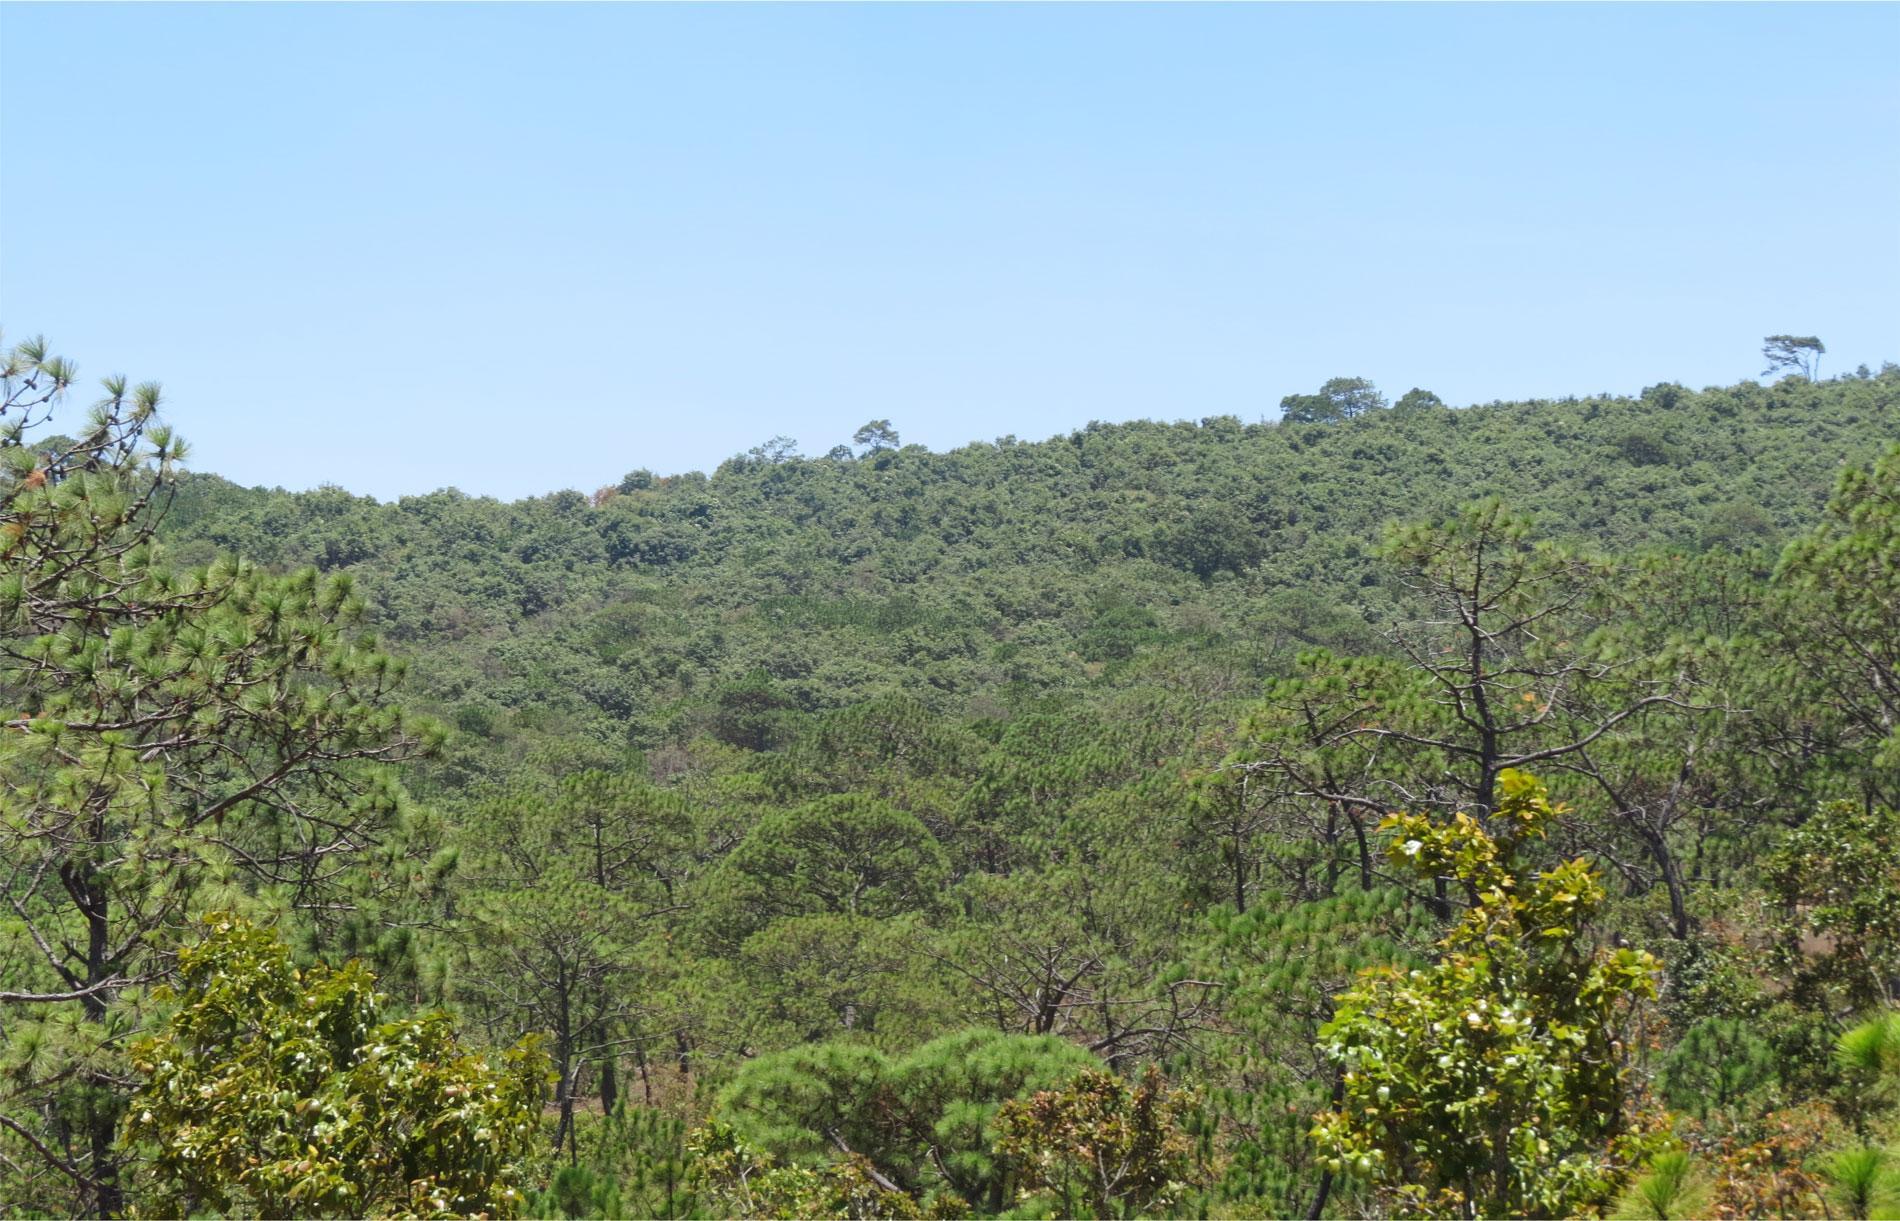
0, 336, 1900, 1217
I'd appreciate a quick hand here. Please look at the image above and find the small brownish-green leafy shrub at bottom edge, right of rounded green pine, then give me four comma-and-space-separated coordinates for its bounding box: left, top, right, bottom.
996, 1067, 1201, 1217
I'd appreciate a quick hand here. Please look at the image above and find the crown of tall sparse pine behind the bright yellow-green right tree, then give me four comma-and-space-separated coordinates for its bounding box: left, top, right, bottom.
1222, 498, 1723, 938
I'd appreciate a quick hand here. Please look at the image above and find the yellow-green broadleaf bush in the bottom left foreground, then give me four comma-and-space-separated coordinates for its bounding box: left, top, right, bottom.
125, 915, 547, 1217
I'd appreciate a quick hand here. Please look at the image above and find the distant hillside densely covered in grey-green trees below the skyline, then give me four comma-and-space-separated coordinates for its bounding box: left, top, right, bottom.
165, 370, 1896, 756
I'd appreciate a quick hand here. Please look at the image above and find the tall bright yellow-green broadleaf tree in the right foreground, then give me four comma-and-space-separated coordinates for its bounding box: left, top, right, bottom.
1313, 771, 1657, 1217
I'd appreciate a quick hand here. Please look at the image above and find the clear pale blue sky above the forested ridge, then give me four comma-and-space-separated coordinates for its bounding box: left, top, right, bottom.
0, 4, 1900, 496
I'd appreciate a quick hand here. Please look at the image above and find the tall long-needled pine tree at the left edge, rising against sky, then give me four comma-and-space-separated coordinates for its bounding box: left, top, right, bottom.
0, 340, 437, 1213
